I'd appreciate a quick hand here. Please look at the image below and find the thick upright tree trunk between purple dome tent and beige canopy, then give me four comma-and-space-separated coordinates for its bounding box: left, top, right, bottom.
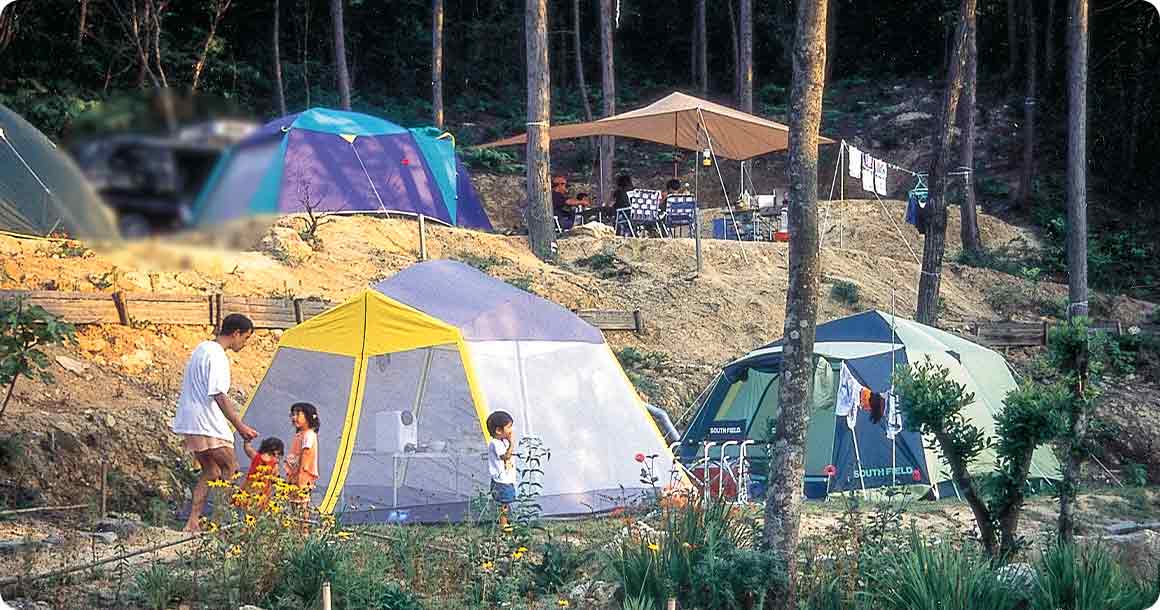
524, 0, 556, 260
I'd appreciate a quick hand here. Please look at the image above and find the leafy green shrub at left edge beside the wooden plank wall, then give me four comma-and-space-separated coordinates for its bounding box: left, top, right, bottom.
0, 299, 77, 414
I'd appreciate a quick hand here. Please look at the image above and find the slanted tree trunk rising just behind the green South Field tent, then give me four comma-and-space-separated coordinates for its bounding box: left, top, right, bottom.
915, 0, 977, 326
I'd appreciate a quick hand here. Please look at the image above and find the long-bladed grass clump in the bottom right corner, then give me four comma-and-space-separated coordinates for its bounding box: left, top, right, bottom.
1031, 544, 1158, 610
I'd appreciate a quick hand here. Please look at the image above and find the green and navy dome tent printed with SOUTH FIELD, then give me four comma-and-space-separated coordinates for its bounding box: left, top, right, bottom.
680, 311, 1059, 498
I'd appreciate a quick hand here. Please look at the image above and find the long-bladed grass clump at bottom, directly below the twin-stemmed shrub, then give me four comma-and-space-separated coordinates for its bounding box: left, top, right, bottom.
868, 533, 1018, 610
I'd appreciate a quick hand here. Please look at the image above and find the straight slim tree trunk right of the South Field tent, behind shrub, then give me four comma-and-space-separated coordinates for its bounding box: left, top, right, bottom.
1059, 0, 1088, 542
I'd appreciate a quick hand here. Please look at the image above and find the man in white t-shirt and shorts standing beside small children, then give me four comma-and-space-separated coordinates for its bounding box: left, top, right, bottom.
171, 313, 258, 531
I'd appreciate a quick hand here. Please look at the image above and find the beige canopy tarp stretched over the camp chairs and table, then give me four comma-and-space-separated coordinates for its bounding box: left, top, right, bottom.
480, 93, 834, 161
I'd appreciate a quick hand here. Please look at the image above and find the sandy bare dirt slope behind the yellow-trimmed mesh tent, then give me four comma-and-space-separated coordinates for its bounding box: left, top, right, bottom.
0, 201, 1148, 507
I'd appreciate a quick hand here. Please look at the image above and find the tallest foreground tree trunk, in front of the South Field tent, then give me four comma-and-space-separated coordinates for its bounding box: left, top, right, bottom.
764, 0, 826, 610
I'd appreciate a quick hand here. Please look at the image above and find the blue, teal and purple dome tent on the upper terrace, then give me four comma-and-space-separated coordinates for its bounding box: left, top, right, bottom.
194, 108, 492, 230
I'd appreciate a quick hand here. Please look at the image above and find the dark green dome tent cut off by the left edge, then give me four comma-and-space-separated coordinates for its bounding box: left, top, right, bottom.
0, 104, 119, 240
